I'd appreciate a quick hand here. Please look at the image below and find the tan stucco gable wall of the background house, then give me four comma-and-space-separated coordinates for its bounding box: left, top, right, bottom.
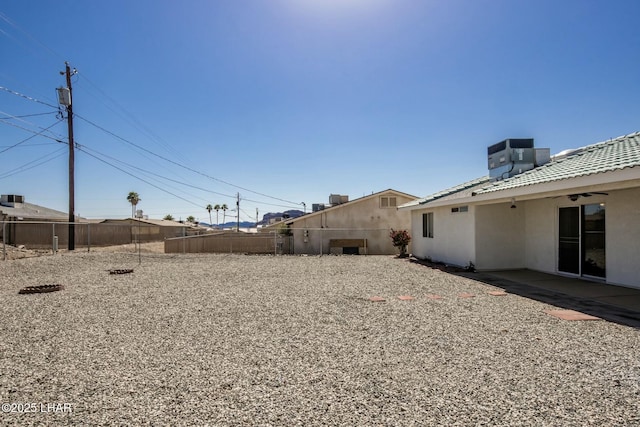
290, 193, 413, 255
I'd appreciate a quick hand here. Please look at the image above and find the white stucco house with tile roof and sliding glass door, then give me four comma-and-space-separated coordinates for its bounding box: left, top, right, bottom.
400, 132, 640, 288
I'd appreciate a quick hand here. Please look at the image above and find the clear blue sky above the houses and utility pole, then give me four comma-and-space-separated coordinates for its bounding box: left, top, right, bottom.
0, 0, 640, 222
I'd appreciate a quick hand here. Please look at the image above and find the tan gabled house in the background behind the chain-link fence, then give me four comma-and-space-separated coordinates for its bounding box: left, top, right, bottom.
274, 189, 415, 255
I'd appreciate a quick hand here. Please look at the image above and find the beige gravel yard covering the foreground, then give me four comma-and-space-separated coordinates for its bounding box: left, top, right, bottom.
0, 252, 640, 426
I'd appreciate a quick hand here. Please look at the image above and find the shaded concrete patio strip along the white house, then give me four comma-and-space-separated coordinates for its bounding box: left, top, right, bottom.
461, 270, 640, 328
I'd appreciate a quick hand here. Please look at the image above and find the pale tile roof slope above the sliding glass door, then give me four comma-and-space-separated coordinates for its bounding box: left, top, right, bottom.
475, 132, 640, 194
